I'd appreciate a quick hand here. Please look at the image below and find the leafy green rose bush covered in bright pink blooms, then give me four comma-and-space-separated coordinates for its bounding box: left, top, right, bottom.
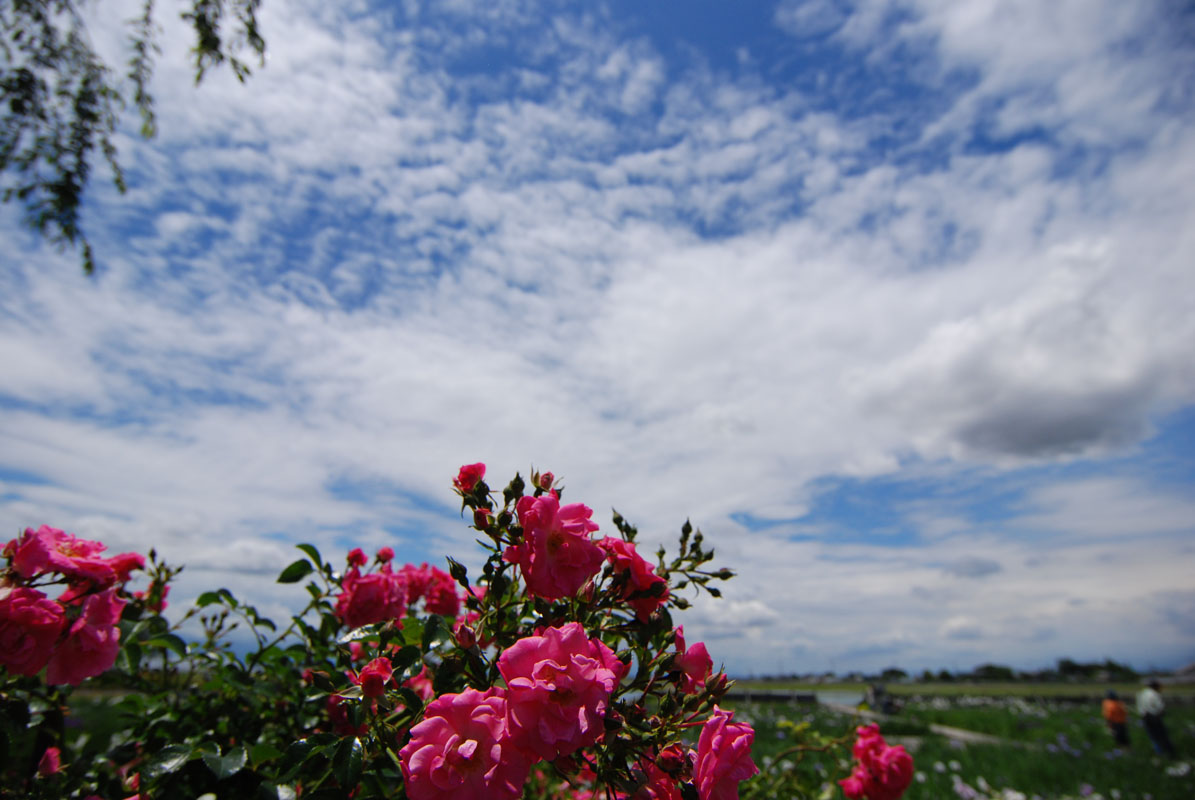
0, 463, 912, 800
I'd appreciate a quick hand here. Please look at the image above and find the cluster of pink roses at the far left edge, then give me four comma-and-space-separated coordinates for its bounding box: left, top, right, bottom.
0, 525, 143, 685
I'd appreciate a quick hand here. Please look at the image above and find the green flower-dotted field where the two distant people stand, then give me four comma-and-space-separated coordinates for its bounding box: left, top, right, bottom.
733, 696, 1195, 800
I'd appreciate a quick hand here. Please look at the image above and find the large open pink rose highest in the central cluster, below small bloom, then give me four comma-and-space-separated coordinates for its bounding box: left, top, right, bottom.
502, 493, 602, 600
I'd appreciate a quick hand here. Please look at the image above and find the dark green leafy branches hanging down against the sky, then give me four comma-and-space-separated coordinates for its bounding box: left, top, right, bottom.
0, 0, 265, 274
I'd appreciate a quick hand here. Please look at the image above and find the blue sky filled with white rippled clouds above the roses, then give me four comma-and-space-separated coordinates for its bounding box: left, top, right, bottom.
0, 0, 1195, 674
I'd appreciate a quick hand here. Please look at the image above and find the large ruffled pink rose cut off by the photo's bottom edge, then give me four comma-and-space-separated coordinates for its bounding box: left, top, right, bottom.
398, 689, 531, 800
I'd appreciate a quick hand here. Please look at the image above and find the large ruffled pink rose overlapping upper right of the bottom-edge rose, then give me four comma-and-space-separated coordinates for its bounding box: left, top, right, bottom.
498, 622, 627, 761
